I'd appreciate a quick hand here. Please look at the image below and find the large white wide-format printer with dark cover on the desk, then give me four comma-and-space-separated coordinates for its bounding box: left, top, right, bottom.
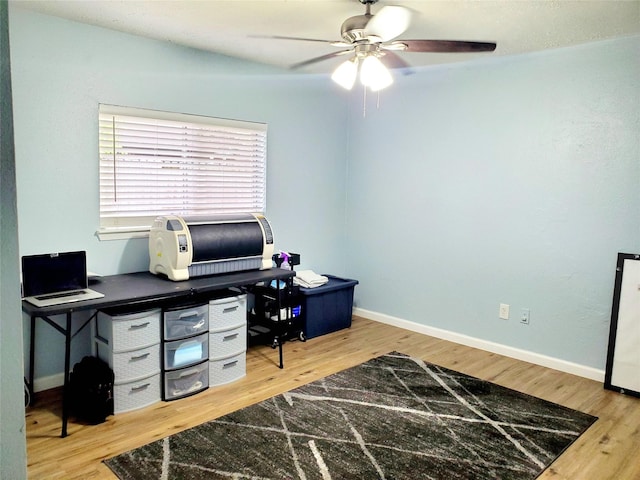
149, 214, 274, 280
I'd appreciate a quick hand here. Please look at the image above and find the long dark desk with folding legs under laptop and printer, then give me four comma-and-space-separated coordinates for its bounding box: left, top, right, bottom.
22, 268, 295, 437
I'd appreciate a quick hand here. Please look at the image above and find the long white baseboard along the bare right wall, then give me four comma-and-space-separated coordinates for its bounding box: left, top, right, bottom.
353, 308, 604, 382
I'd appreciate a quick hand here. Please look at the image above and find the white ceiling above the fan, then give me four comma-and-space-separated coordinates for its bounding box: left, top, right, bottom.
10, 0, 640, 72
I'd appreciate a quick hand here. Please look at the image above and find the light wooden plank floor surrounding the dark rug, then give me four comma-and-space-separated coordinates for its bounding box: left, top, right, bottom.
26, 318, 640, 480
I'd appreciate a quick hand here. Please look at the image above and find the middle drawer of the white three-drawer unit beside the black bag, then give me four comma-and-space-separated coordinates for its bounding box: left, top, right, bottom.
96, 340, 160, 382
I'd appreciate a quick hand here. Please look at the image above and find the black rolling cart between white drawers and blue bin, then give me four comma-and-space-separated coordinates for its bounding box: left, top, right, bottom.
246, 253, 307, 368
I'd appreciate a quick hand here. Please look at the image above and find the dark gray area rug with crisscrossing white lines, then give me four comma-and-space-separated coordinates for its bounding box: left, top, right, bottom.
105, 352, 597, 480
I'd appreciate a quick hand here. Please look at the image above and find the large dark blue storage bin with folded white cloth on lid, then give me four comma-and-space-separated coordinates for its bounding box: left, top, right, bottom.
300, 275, 358, 338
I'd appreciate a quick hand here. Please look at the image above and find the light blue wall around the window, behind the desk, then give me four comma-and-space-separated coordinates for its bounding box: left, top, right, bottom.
10, 5, 347, 378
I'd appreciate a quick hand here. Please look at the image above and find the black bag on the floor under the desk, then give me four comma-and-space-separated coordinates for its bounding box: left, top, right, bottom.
69, 357, 115, 425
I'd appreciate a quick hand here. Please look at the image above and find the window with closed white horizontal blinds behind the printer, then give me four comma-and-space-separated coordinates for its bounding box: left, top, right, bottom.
98, 105, 267, 238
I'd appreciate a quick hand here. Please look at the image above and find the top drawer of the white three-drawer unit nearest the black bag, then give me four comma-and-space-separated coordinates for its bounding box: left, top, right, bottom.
96, 308, 161, 353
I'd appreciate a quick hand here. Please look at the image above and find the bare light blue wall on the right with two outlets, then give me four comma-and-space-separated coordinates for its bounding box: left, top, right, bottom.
347, 37, 640, 369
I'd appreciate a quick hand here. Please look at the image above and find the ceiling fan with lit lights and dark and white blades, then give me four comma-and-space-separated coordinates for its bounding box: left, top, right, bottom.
264, 0, 496, 91
